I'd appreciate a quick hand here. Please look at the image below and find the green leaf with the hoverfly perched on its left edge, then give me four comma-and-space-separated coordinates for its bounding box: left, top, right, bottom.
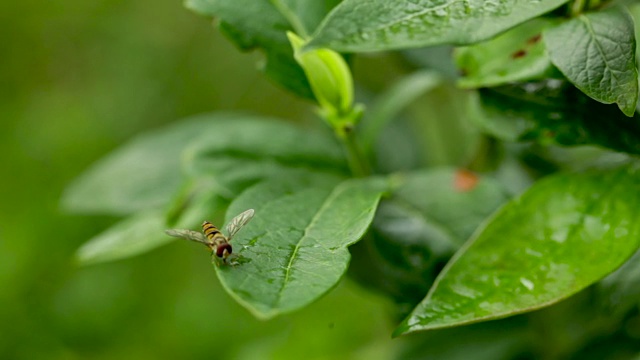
216, 177, 387, 318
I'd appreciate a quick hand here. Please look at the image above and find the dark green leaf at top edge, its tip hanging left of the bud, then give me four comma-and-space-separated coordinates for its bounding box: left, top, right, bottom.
185, 0, 336, 98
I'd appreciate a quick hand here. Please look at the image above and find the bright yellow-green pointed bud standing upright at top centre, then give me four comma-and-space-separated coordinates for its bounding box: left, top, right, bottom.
287, 32, 353, 122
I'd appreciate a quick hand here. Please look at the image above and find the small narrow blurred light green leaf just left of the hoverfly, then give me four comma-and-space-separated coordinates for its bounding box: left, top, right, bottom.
76, 210, 173, 265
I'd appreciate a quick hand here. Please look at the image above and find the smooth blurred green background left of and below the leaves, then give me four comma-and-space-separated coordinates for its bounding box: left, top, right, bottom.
0, 0, 403, 359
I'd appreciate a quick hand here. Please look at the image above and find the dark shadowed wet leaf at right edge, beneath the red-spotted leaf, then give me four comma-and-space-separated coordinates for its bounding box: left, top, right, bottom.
478, 80, 640, 154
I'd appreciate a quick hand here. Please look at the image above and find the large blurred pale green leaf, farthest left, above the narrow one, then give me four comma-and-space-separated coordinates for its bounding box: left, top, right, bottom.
62, 113, 246, 214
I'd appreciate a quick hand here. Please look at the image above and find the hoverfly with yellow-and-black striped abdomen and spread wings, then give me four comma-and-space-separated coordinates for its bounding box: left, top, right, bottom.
165, 209, 254, 265
